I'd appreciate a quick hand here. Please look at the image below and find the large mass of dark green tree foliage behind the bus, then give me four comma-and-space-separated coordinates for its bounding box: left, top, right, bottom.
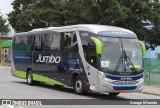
8, 0, 160, 45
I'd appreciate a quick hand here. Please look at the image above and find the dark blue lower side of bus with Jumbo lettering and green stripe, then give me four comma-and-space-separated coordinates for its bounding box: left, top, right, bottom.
12, 51, 89, 90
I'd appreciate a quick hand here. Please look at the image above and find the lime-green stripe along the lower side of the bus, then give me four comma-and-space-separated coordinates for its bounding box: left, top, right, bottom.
16, 70, 65, 86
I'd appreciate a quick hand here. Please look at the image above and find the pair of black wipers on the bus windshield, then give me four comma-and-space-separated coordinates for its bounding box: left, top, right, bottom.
114, 50, 137, 72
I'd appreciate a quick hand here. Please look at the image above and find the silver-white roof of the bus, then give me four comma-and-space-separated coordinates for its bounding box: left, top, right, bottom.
13, 24, 137, 38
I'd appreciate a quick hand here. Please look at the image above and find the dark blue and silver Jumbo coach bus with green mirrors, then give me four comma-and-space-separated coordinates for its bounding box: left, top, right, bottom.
12, 24, 145, 95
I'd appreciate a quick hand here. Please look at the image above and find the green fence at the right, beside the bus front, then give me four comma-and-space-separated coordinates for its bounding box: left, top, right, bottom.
144, 58, 160, 86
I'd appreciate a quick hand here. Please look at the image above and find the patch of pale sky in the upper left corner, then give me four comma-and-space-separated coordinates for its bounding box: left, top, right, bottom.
0, 0, 14, 18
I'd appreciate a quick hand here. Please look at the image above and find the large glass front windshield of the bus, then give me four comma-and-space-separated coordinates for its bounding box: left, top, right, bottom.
99, 37, 142, 72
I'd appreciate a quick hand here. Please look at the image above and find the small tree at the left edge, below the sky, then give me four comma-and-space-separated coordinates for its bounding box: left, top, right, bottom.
0, 14, 9, 34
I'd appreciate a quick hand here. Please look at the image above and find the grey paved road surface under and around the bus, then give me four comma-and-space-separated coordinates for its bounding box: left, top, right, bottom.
0, 67, 160, 107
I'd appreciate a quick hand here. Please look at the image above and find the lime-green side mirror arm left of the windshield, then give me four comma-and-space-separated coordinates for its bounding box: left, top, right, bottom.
91, 37, 102, 54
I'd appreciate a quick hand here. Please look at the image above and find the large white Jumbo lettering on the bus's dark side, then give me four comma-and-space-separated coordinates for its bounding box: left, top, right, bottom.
36, 54, 61, 63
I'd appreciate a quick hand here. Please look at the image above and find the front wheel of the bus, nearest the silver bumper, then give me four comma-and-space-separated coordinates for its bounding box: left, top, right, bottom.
73, 76, 85, 95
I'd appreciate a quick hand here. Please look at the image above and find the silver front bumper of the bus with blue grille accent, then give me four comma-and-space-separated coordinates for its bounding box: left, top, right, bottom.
97, 78, 144, 93
